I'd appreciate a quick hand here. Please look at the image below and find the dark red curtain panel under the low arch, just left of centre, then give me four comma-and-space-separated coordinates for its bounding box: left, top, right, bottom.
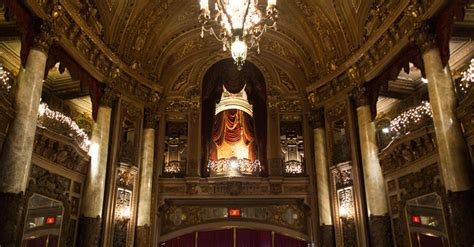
198, 229, 234, 247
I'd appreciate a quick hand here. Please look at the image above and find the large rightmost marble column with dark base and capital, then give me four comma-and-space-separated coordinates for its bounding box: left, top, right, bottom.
416, 30, 474, 246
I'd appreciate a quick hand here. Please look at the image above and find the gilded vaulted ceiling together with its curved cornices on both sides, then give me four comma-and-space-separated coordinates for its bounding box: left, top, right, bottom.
3, 0, 472, 106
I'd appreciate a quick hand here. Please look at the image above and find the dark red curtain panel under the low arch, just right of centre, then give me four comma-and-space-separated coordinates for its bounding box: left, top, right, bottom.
236, 228, 272, 247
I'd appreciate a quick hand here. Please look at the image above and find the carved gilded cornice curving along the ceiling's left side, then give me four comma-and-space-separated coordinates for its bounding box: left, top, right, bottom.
26, 0, 163, 107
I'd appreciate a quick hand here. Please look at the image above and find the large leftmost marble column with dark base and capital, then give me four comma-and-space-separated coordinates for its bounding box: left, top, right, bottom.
0, 24, 54, 246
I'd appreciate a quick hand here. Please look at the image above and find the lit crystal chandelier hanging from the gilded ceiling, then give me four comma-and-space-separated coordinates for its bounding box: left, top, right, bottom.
199, 0, 278, 70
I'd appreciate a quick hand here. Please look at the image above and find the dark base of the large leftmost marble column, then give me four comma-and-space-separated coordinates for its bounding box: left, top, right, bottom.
0, 192, 25, 247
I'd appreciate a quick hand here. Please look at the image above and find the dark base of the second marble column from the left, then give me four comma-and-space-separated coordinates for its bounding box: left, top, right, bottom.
76, 216, 102, 247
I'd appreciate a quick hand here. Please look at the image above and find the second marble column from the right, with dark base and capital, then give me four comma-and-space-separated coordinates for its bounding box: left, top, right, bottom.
353, 88, 392, 246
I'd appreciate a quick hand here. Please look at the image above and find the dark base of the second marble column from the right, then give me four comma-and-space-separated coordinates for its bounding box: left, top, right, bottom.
369, 216, 393, 246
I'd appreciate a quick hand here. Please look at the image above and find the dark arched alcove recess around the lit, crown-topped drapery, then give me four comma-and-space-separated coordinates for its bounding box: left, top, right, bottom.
201, 59, 268, 176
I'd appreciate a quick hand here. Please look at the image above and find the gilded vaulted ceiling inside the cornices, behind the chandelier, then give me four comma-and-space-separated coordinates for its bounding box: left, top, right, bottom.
76, 0, 392, 92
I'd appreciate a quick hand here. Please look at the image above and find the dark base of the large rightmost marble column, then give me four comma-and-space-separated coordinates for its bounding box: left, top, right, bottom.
446, 189, 474, 246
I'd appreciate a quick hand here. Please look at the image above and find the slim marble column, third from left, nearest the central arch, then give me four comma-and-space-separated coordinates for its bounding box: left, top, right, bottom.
135, 109, 158, 247
